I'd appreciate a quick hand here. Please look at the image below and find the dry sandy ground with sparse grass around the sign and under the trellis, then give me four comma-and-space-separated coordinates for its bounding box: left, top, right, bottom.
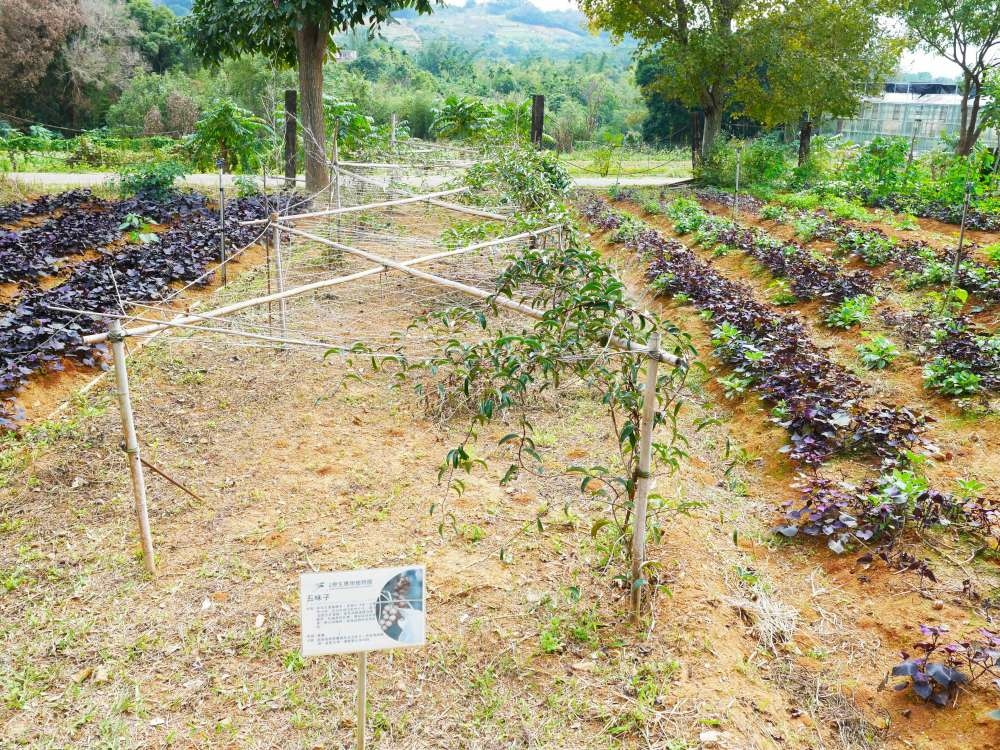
0, 181, 952, 748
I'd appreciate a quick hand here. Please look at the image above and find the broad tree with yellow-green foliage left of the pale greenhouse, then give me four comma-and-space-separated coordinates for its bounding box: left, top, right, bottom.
580, 0, 896, 153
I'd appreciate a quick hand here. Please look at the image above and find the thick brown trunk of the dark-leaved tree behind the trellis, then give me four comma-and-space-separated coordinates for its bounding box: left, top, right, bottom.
295, 20, 330, 193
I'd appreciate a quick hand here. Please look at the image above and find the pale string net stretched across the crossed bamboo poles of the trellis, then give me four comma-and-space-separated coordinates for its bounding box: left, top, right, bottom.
120, 167, 559, 374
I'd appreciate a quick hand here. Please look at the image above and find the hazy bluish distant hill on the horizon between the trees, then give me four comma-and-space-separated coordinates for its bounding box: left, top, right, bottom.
159, 0, 635, 60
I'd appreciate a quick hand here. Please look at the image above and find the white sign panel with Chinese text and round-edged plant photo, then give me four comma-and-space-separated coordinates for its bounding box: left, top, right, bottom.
299, 565, 426, 656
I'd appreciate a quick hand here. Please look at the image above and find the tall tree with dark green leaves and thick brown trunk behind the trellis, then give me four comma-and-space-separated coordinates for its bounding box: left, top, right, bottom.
186, 0, 431, 191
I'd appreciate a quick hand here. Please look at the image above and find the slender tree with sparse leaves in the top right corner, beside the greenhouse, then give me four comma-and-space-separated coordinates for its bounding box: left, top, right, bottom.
901, 0, 1000, 156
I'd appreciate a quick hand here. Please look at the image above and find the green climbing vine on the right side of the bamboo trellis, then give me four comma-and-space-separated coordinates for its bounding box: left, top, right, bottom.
358, 150, 695, 612
